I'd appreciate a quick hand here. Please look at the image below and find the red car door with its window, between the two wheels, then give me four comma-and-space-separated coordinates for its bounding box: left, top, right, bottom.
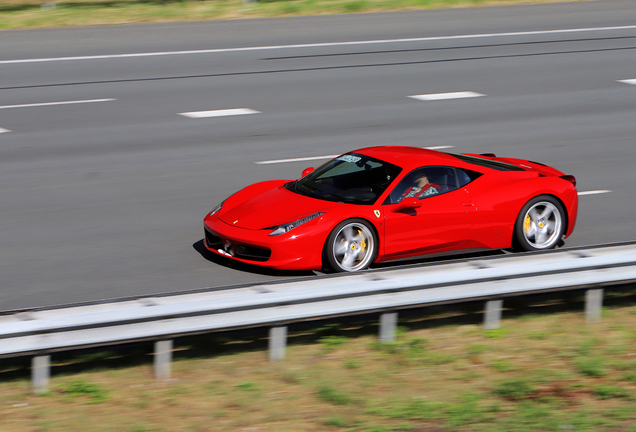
383, 167, 475, 260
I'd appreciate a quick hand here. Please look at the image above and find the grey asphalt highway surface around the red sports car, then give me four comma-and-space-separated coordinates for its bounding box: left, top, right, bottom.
0, 0, 636, 311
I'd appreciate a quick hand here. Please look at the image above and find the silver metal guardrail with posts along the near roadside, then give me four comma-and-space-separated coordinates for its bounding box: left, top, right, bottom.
0, 242, 636, 391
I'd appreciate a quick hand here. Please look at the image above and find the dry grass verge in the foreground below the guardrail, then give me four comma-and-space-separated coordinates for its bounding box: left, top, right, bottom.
0, 291, 636, 432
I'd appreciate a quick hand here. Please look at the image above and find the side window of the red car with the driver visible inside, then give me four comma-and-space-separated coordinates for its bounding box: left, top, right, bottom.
385, 167, 460, 204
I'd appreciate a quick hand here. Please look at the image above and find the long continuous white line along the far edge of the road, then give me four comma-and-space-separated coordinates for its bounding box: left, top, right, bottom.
0, 25, 636, 64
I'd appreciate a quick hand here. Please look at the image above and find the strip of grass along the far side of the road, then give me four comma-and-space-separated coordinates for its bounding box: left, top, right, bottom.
0, 0, 588, 30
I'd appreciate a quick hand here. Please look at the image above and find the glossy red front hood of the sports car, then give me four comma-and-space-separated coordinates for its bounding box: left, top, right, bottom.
219, 185, 337, 230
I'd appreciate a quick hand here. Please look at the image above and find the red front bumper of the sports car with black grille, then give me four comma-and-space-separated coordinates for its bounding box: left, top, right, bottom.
203, 215, 327, 270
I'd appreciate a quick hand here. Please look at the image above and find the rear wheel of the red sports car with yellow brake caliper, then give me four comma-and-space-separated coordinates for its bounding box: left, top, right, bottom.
514, 195, 566, 251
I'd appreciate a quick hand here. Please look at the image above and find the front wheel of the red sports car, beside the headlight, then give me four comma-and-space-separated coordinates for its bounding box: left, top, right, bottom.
325, 219, 378, 272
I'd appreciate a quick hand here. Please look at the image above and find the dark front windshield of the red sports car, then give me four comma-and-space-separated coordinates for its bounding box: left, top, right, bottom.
286, 153, 402, 205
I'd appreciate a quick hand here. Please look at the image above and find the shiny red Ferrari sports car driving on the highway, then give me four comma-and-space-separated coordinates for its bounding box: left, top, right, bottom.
204, 146, 578, 272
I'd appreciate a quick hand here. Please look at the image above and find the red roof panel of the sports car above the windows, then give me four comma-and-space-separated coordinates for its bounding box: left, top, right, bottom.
353, 146, 464, 169
